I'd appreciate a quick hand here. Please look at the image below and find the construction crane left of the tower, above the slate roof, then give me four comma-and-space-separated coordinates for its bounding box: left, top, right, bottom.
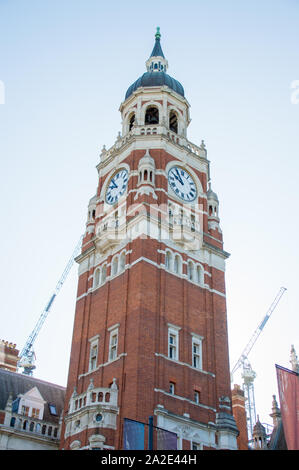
18, 235, 83, 375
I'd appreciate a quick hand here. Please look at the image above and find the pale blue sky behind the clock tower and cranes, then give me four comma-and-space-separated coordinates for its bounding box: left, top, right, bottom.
0, 0, 299, 423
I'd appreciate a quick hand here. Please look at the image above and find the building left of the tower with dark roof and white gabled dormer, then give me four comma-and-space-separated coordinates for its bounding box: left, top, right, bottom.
0, 341, 65, 450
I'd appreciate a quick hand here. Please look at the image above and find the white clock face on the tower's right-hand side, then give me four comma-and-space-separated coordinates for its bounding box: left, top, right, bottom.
168, 166, 197, 202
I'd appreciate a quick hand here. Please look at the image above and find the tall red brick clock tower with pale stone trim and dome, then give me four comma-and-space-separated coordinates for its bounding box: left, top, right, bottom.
61, 29, 238, 449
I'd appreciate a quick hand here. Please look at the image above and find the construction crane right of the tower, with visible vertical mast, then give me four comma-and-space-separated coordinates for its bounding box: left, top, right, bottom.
231, 287, 286, 440
